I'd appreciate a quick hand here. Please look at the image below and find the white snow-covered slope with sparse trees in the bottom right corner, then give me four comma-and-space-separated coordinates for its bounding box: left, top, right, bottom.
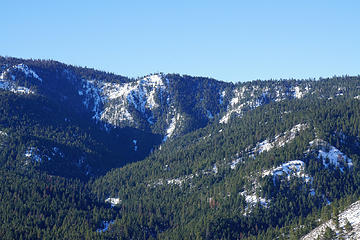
301, 201, 360, 240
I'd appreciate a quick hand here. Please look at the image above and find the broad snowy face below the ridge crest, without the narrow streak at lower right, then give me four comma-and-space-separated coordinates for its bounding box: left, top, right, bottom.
79, 74, 169, 127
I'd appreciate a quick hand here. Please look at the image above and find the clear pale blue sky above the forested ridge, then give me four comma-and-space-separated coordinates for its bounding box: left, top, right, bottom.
0, 0, 360, 82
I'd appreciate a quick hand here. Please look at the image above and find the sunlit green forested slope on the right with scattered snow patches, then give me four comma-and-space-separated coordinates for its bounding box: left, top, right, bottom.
93, 98, 360, 239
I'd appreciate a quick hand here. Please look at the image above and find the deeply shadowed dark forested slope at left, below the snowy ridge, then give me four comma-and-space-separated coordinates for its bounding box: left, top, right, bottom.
0, 90, 161, 178
